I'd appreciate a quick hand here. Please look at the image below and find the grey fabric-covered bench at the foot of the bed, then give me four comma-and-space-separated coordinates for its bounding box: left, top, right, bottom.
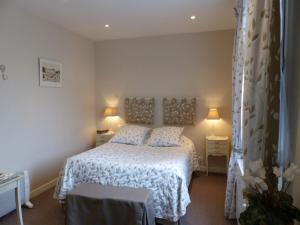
66, 184, 155, 225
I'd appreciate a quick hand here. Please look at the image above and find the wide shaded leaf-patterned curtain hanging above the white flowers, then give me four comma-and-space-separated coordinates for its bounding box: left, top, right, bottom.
242, 0, 281, 190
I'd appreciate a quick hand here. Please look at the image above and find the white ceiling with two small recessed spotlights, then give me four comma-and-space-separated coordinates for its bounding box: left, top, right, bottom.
16, 0, 235, 40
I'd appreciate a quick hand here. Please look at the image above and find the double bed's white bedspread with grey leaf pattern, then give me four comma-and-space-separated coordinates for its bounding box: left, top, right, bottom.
54, 136, 198, 222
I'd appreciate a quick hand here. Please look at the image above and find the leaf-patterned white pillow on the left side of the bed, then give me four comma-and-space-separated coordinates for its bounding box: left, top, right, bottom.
110, 125, 150, 145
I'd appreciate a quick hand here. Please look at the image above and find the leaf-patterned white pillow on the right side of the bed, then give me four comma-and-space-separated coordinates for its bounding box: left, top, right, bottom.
148, 127, 184, 147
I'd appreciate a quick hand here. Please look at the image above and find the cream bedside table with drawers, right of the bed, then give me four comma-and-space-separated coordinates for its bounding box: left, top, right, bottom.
205, 136, 229, 175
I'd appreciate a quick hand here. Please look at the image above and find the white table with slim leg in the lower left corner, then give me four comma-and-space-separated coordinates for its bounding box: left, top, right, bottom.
0, 176, 24, 225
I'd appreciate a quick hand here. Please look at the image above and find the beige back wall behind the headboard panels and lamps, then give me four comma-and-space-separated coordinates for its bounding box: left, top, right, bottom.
96, 30, 234, 170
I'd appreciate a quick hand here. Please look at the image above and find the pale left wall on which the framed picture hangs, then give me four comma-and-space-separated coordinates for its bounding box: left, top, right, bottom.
0, 0, 96, 188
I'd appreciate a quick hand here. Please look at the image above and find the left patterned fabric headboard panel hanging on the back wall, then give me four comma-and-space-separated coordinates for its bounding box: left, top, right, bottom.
124, 98, 155, 124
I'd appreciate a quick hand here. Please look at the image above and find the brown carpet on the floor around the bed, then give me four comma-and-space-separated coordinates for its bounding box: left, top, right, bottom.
0, 174, 236, 225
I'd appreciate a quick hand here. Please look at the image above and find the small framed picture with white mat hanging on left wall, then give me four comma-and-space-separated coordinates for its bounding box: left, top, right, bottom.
39, 58, 62, 87
